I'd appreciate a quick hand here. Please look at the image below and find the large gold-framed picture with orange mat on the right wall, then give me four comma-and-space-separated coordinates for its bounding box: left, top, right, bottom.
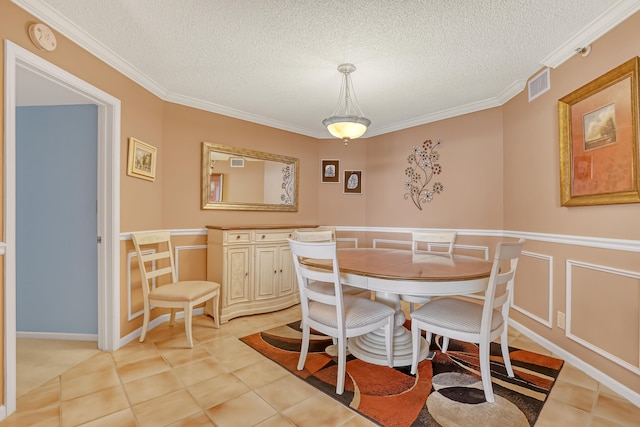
558, 57, 640, 206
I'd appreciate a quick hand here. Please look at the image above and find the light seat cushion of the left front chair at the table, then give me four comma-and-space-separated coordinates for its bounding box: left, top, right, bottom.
309, 295, 395, 329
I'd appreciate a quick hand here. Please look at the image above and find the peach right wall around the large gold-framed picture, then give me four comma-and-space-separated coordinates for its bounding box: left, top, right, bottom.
502, 13, 640, 393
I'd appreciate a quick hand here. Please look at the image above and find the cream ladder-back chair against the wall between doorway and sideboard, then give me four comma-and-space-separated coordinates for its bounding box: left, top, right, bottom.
131, 231, 220, 348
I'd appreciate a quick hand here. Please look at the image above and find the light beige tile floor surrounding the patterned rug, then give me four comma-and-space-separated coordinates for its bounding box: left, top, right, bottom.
0, 306, 640, 427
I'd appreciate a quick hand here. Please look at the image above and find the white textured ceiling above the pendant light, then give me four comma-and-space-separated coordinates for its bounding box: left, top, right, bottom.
13, 0, 640, 138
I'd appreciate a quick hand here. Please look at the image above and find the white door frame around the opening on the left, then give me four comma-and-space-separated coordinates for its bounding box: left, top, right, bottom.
0, 40, 120, 420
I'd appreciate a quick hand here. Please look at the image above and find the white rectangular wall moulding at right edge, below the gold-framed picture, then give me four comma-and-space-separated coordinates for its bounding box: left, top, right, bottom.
565, 259, 640, 375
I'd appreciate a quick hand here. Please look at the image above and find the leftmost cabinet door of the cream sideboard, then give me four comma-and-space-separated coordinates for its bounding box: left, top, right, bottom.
223, 246, 251, 306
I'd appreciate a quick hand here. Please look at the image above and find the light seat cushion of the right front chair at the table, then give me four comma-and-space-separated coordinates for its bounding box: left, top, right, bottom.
411, 298, 503, 334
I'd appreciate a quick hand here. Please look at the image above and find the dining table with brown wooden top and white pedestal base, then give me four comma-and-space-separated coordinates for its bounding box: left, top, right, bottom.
303, 248, 492, 366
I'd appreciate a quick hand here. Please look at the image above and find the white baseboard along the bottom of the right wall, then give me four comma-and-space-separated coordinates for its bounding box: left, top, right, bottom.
509, 319, 640, 407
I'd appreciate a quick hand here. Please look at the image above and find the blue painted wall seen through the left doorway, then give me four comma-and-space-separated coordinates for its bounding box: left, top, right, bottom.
16, 105, 98, 334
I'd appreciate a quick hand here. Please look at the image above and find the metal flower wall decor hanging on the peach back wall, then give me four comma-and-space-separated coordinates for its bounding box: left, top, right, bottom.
404, 139, 444, 210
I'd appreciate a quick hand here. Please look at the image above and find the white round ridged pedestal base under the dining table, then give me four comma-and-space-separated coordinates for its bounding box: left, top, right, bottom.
348, 292, 429, 366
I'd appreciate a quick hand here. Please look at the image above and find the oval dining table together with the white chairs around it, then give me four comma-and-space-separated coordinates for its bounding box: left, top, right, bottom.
289, 230, 525, 402
